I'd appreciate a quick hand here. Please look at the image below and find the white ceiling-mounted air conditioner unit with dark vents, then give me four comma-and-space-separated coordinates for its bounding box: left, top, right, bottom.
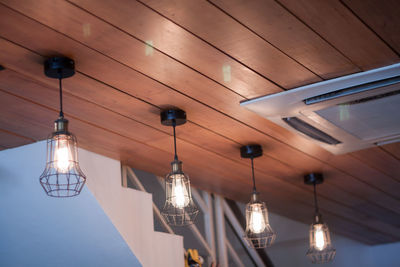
241, 64, 400, 154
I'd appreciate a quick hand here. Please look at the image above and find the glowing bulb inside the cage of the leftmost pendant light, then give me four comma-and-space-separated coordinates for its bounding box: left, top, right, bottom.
54, 136, 73, 173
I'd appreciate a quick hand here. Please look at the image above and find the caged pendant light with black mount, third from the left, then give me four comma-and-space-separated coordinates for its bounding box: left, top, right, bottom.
240, 145, 276, 249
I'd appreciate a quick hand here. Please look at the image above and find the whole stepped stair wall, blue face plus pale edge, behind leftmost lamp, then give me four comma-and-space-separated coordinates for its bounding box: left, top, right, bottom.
0, 142, 184, 267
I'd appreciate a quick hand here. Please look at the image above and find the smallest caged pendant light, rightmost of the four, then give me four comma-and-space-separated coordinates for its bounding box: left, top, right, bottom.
304, 173, 336, 263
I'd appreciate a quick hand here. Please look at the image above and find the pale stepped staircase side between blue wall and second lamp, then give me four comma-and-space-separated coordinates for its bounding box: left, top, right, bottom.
79, 150, 184, 267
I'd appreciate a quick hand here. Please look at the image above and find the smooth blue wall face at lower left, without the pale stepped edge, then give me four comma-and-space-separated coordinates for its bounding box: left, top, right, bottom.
0, 142, 141, 267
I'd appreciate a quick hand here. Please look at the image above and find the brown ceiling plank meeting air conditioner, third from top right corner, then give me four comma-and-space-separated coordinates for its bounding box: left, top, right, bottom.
200, 0, 360, 79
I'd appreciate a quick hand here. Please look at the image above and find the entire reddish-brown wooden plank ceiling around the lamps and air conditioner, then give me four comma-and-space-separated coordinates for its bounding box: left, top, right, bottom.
0, 0, 400, 244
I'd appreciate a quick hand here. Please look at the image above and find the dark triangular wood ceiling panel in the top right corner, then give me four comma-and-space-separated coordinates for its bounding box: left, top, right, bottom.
342, 0, 400, 53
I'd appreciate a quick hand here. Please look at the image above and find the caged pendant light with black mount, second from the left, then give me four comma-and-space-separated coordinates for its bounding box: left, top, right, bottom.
161, 109, 199, 226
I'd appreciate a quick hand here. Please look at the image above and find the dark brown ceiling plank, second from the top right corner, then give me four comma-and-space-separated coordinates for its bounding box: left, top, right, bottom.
278, 0, 399, 70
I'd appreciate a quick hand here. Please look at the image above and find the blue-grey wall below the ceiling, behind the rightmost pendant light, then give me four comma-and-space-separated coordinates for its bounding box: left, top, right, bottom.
267, 213, 400, 267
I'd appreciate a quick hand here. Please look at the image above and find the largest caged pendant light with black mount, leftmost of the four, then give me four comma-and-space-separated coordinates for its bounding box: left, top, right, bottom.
39, 57, 86, 197
